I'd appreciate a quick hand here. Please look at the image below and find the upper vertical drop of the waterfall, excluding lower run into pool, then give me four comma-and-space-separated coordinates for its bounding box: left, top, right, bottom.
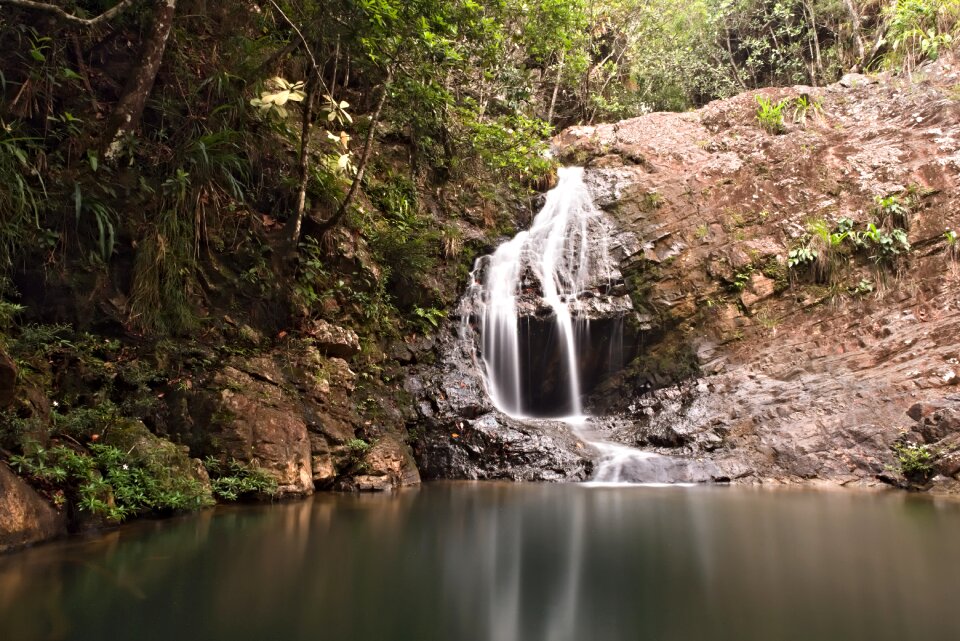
461, 167, 619, 418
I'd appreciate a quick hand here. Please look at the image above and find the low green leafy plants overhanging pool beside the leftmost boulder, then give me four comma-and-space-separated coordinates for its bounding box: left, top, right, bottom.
10, 444, 209, 522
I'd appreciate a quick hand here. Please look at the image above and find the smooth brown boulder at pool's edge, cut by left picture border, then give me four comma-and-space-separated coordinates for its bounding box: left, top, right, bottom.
0, 463, 67, 553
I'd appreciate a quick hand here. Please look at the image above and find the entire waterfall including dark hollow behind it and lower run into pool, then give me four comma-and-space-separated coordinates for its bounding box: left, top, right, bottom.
460, 167, 700, 484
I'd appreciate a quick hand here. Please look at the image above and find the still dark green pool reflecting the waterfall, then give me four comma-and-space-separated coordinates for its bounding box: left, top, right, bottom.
0, 483, 960, 641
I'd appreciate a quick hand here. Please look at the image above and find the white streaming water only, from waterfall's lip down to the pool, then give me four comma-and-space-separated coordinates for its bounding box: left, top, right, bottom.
461, 167, 688, 485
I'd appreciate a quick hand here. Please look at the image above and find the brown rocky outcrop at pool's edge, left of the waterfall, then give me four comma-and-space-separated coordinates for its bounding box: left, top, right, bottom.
179, 340, 420, 496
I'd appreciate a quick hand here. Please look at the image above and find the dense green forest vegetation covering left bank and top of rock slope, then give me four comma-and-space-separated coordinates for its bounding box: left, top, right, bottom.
0, 0, 960, 518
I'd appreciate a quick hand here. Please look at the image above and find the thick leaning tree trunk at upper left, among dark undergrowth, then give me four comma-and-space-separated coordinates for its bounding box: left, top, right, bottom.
101, 0, 177, 162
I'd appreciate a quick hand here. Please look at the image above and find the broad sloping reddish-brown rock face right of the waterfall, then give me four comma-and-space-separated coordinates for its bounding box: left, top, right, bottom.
544, 56, 960, 484
